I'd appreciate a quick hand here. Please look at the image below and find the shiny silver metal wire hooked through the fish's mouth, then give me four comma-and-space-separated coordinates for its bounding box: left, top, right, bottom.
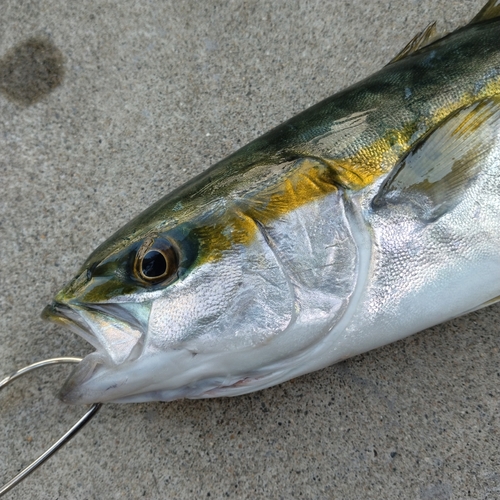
0, 358, 102, 497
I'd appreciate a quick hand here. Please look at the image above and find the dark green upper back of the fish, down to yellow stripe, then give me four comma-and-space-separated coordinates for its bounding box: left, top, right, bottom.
86, 14, 500, 265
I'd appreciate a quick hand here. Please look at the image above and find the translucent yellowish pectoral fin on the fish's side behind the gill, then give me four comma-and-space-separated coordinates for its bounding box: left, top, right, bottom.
372, 97, 500, 221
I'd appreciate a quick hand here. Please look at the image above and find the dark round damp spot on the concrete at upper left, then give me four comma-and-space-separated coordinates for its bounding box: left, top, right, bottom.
0, 37, 64, 106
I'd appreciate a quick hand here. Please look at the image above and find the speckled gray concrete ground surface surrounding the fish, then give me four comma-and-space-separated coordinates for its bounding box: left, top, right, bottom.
0, 0, 500, 500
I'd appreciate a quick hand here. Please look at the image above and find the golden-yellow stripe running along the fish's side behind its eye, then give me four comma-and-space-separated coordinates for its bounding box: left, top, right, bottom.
198, 81, 500, 264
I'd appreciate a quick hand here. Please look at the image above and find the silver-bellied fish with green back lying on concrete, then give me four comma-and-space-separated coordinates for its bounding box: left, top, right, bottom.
42, 0, 500, 404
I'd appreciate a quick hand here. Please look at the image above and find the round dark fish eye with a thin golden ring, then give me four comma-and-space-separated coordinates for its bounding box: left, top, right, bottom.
134, 239, 178, 284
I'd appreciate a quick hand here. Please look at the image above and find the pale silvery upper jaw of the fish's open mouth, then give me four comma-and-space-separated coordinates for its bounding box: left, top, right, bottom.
42, 301, 149, 365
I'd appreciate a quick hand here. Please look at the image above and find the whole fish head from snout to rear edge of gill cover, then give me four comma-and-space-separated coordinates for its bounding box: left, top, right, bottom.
43, 154, 356, 403
